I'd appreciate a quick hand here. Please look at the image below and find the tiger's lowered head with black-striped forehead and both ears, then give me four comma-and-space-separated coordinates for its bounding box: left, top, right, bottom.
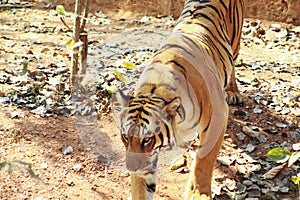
112, 91, 180, 176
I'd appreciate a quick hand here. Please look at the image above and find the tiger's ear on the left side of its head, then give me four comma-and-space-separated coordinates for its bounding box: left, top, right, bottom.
111, 90, 130, 126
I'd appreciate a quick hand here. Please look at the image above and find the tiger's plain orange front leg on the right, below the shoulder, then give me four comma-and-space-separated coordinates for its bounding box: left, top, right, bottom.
184, 123, 227, 200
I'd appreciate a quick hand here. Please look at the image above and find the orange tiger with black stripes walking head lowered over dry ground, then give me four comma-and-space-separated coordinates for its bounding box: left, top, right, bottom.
112, 0, 244, 200
